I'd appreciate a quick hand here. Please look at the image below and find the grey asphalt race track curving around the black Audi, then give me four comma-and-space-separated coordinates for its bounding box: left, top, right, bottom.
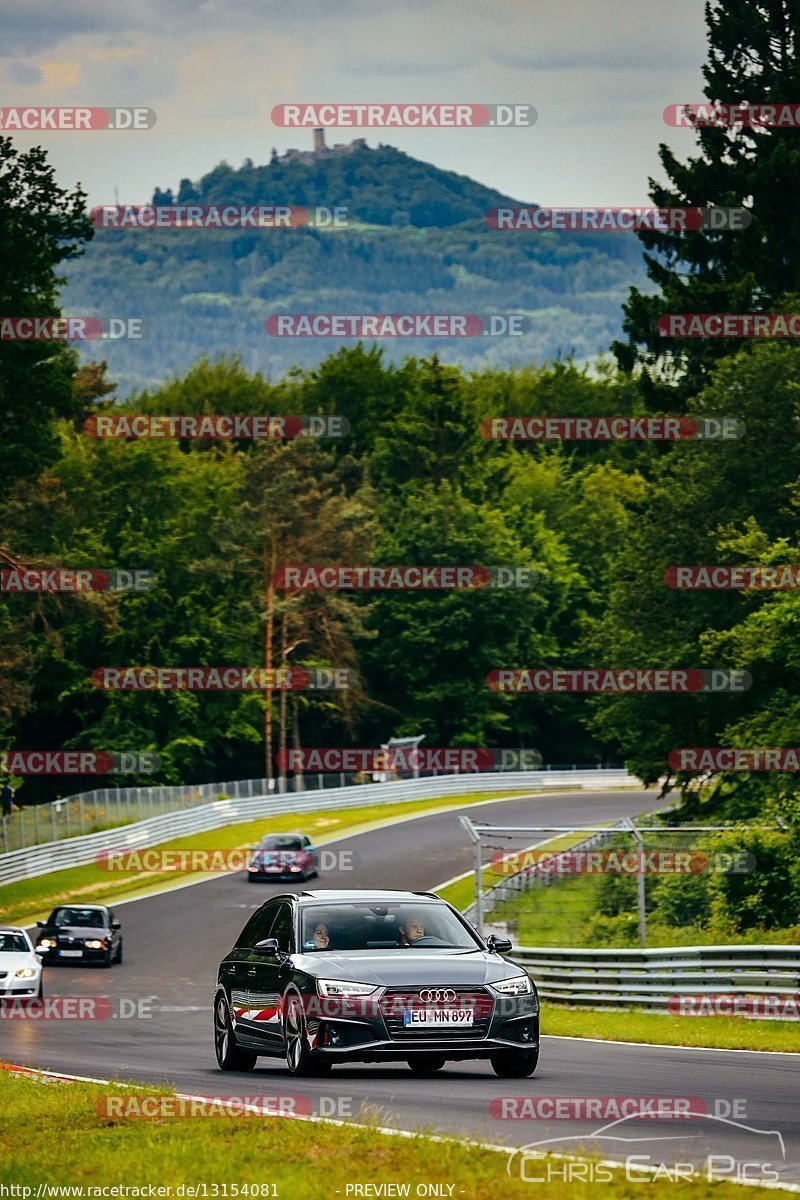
0, 792, 800, 1183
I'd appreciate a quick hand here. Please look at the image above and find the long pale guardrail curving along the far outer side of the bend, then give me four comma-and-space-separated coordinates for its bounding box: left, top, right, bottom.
0, 768, 642, 884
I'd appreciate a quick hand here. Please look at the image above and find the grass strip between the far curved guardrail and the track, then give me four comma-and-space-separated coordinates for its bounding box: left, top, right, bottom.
0, 792, 527, 925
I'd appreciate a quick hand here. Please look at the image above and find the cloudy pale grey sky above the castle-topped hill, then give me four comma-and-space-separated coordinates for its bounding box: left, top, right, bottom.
0, 0, 705, 206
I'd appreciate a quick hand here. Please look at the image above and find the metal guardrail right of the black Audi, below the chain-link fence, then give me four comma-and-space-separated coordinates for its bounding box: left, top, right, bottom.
511, 946, 800, 1019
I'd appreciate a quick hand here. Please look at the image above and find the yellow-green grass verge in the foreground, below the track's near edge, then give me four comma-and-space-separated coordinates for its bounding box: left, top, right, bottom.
0, 1070, 758, 1200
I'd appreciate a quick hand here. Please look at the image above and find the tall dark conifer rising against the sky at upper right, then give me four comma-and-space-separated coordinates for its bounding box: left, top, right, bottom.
614, 0, 800, 400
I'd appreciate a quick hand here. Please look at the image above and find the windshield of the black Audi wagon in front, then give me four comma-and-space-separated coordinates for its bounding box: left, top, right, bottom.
300, 901, 479, 954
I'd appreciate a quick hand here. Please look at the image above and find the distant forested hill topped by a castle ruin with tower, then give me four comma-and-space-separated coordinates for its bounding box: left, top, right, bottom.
62, 145, 644, 394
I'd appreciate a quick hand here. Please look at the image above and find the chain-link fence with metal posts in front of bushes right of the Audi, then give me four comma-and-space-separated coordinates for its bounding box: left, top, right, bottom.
461, 817, 786, 948
